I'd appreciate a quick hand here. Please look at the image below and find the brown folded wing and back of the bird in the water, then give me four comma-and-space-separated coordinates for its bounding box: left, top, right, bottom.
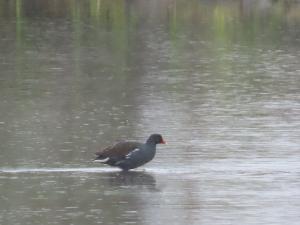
95, 141, 140, 158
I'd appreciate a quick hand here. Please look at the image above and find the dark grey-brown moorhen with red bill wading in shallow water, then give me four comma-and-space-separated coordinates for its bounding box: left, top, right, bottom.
94, 134, 166, 171
